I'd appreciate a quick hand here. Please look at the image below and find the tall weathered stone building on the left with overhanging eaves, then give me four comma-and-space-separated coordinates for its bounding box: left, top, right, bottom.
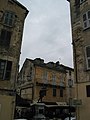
0, 0, 28, 120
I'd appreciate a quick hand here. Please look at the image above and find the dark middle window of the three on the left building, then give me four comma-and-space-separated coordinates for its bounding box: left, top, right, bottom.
0, 29, 11, 47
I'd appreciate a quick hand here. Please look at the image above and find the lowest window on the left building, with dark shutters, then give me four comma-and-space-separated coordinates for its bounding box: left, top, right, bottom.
0, 59, 12, 80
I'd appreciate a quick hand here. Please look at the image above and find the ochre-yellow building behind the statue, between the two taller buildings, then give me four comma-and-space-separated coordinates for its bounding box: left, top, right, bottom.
18, 58, 74, 105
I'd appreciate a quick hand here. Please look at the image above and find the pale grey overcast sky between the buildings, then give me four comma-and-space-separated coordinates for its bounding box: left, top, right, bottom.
18, 0, 73, 67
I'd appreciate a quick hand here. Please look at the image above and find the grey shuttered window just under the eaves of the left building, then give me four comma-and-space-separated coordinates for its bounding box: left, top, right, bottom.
4, 11, 15, 27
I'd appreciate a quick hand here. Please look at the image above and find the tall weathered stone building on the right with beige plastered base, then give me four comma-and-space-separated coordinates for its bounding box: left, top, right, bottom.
68, 0, 90, 120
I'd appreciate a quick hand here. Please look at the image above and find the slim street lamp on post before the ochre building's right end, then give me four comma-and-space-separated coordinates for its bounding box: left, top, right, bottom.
68, 79, 73, 120
